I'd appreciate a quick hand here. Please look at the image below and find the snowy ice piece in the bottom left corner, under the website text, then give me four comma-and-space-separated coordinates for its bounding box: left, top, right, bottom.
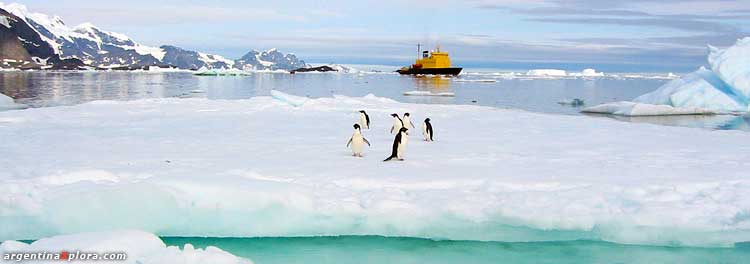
0, 230, 253, 264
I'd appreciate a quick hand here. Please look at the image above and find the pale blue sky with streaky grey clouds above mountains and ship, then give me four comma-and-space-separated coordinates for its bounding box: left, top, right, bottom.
5, 0, 750, 72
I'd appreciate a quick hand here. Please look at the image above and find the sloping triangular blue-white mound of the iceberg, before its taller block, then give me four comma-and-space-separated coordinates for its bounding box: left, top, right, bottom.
633, 67, 747, 111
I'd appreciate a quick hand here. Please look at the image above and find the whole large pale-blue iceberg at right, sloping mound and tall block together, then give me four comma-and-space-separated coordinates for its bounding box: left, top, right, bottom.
584, 37, 750, 115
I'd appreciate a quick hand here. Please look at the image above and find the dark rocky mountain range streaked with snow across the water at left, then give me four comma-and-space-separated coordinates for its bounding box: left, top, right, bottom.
0, 3, 306, 70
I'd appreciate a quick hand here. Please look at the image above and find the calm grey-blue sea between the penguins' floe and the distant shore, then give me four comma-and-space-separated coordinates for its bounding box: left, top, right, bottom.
0, 70, 750, 131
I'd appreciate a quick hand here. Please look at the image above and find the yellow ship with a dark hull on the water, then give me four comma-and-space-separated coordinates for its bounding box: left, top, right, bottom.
397, 44, 463, 75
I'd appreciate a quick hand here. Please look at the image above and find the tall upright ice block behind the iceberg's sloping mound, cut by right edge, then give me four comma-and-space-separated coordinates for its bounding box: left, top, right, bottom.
708, 37, 750, 98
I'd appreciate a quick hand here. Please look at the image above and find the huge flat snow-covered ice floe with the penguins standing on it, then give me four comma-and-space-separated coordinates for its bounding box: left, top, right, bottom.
0, 91, 750, 246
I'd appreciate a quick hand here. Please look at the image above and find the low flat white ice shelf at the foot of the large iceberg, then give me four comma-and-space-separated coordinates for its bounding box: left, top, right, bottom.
582, 101, 716, 116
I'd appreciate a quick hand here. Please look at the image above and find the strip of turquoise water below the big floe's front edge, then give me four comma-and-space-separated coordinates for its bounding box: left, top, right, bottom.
162, 236, 750, 264
